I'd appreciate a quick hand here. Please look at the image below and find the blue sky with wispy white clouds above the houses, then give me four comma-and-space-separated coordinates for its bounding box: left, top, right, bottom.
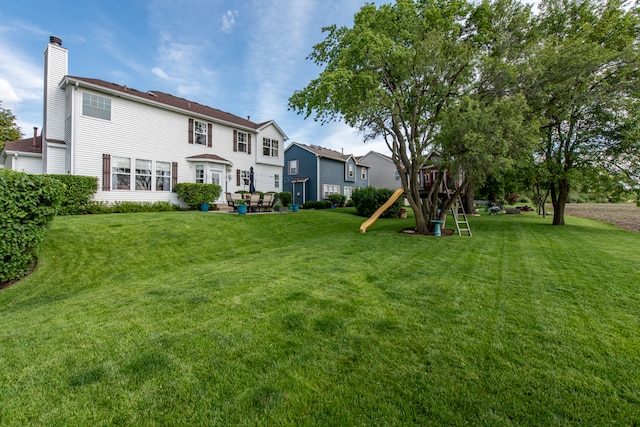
0, 0, 387, 155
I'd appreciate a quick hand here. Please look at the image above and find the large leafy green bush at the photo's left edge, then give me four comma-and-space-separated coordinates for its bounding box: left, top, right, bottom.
0, 169, 64, 282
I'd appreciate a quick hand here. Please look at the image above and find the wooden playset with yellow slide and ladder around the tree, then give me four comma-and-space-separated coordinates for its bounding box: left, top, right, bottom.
360, 154, 471, 237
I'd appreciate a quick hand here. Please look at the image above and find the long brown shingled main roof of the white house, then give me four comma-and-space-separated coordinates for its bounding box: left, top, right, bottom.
61, 76, 272, 131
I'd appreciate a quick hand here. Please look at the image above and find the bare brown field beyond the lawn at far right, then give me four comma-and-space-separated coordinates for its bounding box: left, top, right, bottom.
565, 203, 640, 232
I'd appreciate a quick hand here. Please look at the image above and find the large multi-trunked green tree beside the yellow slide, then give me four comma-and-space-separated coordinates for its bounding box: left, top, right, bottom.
289, 0, 529, 232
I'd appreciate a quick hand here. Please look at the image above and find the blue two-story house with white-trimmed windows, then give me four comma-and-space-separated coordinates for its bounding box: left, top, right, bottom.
283, 142, 369, 203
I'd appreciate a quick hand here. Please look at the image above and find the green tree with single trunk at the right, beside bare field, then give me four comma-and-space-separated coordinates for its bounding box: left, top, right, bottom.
528, 0, 640, 225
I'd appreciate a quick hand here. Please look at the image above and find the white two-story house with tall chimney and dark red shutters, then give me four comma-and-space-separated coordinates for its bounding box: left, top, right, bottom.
0, 37, 287, 203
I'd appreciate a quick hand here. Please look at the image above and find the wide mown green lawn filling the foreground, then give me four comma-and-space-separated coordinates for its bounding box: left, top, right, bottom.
0, 209, 640, 426
